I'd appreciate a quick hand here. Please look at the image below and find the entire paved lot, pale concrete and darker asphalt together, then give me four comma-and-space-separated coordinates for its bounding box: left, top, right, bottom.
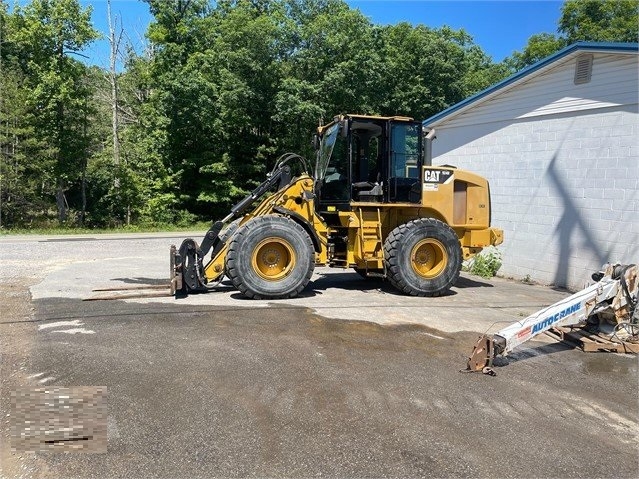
0, 235, 639, 478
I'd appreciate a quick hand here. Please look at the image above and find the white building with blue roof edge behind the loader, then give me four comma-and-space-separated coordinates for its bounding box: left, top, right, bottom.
424, 43, 639, 289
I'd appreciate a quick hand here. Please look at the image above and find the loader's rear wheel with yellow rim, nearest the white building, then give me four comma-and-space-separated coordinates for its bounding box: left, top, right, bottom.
384, 218, 462, 296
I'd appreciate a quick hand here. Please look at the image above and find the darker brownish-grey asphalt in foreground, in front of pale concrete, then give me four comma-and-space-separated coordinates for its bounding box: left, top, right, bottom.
6, 300, 639, 477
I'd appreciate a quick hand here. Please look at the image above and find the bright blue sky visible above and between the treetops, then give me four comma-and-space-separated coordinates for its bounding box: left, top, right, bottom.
80, 0, 563, 66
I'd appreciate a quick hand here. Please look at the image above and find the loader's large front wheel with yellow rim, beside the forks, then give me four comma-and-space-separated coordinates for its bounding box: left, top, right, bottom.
226, 215, 315, 299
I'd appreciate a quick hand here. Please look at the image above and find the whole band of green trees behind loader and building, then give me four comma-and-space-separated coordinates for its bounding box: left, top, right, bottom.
0, 0, 637, 228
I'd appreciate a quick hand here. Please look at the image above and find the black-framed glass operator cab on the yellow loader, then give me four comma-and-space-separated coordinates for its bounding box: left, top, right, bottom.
315, 115, 423, 211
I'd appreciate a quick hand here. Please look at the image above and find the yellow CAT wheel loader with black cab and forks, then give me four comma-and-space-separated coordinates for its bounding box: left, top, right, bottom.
171, 115, 503, 299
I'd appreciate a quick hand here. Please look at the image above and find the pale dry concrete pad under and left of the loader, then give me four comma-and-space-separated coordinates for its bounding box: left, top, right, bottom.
17, 235, 570, 333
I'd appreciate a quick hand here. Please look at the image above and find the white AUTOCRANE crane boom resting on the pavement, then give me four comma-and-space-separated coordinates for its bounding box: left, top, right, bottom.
466, 264, 639, 373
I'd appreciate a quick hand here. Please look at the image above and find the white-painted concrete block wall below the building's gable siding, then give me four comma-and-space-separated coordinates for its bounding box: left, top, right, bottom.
433, 105, 639, 290
